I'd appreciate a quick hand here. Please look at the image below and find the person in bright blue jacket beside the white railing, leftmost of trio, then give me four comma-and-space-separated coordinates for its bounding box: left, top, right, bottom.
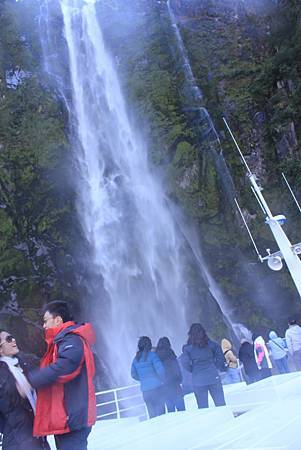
131, 336, 165, 419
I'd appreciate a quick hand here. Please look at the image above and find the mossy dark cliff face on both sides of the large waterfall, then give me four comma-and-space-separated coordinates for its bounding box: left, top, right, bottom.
0, 0, 301, 362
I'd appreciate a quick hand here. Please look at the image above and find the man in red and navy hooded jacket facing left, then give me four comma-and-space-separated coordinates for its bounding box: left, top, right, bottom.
29, 301, 96, 450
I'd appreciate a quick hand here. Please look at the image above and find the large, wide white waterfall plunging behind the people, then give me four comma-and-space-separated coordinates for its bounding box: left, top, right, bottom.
60, 0, 195, 382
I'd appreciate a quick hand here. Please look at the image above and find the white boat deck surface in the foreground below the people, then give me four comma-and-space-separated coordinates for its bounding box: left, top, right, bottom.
49, 373, 301, 450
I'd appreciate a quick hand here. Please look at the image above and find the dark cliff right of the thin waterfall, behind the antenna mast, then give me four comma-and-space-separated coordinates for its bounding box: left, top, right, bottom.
170, 1, 300, 282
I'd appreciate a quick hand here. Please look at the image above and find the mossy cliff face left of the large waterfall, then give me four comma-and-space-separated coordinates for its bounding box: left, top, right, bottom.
0, 1, 83, 353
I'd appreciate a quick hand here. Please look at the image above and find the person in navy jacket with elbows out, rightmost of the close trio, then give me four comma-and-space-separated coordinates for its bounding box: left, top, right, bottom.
182, 323, 226, 408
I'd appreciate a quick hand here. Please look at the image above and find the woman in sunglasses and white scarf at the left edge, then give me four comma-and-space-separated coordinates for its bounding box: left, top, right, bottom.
0, 330, 50, 450
